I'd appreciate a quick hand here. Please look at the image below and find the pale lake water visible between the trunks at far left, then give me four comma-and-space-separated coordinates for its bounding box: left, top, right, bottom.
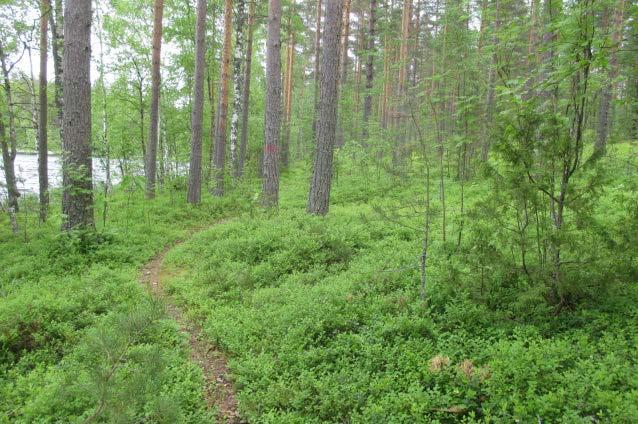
0, 153, 121, 197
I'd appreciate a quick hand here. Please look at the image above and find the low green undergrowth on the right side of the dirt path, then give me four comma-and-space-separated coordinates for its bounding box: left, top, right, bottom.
166, 157, 638, 423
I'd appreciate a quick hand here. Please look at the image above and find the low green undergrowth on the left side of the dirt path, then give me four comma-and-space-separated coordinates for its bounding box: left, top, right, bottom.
0, 189, 248, 423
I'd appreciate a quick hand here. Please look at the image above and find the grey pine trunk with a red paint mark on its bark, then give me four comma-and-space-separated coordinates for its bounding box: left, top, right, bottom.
262, 0, 281, 207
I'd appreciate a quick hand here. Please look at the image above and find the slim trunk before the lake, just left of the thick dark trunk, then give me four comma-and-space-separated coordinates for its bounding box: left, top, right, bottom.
38, 0, 52, 222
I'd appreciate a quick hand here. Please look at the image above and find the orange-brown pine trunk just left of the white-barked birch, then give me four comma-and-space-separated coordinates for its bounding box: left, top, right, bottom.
213, 0, 233, 196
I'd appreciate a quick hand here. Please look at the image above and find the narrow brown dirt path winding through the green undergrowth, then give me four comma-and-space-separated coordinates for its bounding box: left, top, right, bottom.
140, 240, 242, 424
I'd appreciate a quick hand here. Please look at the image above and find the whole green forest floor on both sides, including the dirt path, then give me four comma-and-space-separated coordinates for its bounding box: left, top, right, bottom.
0, 149, 638, 424
